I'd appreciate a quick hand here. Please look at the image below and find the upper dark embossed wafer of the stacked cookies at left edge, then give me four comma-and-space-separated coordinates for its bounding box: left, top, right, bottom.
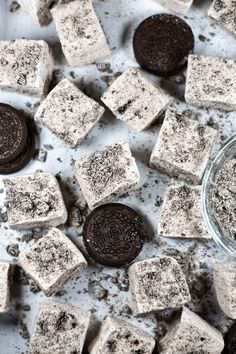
0, 103, 28, 164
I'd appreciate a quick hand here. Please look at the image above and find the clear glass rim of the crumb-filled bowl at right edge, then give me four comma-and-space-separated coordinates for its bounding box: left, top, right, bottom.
201, 135, 236, 257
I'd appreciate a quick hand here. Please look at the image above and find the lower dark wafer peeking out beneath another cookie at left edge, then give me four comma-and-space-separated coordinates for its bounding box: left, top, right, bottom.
0, 122, 35, 174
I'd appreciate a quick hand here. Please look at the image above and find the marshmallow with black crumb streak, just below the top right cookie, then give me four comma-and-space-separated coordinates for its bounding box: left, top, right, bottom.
101, 68, 173, 132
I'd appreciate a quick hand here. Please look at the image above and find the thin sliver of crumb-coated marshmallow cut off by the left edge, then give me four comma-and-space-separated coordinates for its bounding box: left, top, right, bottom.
0, 261, 12, 313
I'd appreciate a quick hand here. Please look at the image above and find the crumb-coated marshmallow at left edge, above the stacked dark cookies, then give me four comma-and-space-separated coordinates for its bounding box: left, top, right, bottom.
0, 39, 53, 96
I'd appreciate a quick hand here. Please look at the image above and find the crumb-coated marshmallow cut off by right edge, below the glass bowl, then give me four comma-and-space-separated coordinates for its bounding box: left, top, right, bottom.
213, 261, 236, 319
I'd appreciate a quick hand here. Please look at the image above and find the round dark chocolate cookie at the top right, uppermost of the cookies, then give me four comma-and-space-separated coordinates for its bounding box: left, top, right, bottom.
133, 14, 194, 76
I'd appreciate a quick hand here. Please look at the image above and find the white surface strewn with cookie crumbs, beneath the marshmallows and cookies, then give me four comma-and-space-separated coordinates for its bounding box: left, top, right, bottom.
0, 0, 236, 354
